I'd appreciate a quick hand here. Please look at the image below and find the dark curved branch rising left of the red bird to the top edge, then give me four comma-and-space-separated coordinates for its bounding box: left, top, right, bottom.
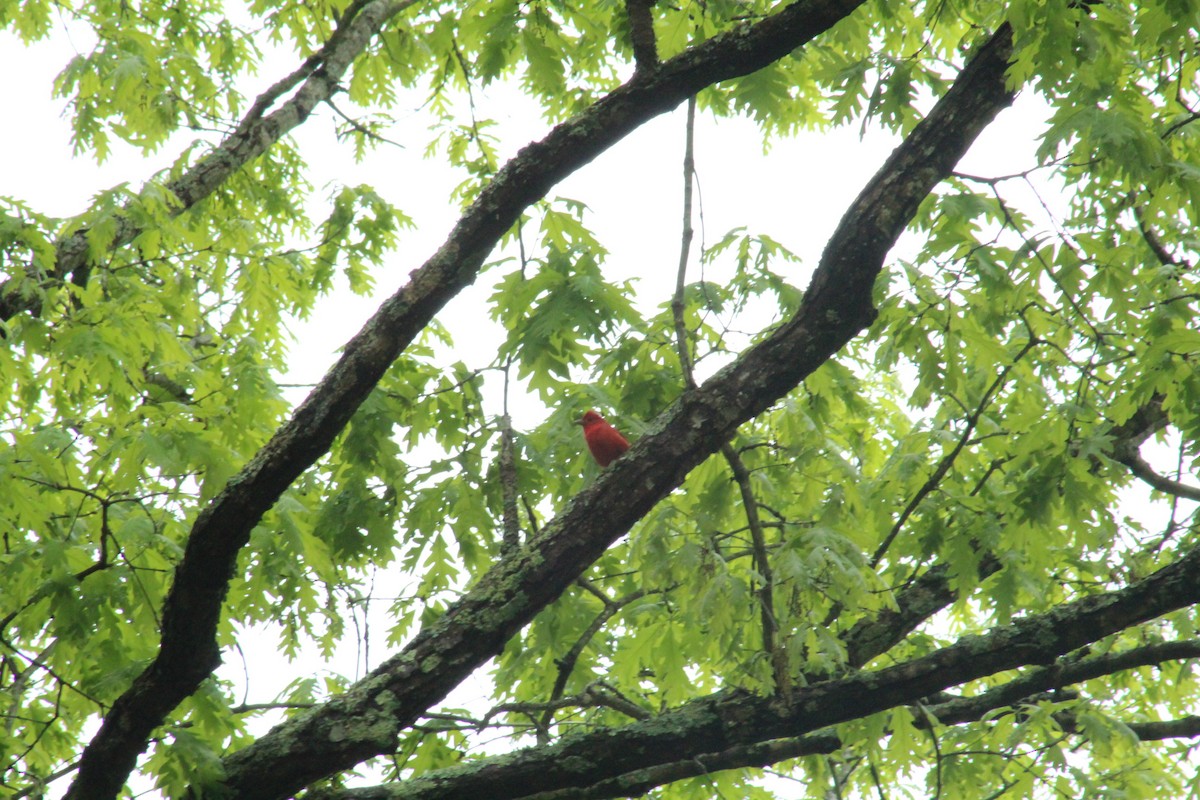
67, 0, 878, 800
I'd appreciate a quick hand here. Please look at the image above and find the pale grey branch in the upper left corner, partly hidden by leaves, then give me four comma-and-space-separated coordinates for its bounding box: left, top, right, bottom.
0, 0, 416, 321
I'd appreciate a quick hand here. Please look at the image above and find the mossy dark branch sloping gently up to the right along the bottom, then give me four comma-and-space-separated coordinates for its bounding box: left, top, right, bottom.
302, 548, 1200, 800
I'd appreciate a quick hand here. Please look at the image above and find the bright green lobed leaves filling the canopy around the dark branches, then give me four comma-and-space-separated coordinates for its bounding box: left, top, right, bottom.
0, 0, 1200, 798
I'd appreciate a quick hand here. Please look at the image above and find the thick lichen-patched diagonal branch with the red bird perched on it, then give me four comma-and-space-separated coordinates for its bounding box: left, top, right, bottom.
206, 20, 1020, 798
